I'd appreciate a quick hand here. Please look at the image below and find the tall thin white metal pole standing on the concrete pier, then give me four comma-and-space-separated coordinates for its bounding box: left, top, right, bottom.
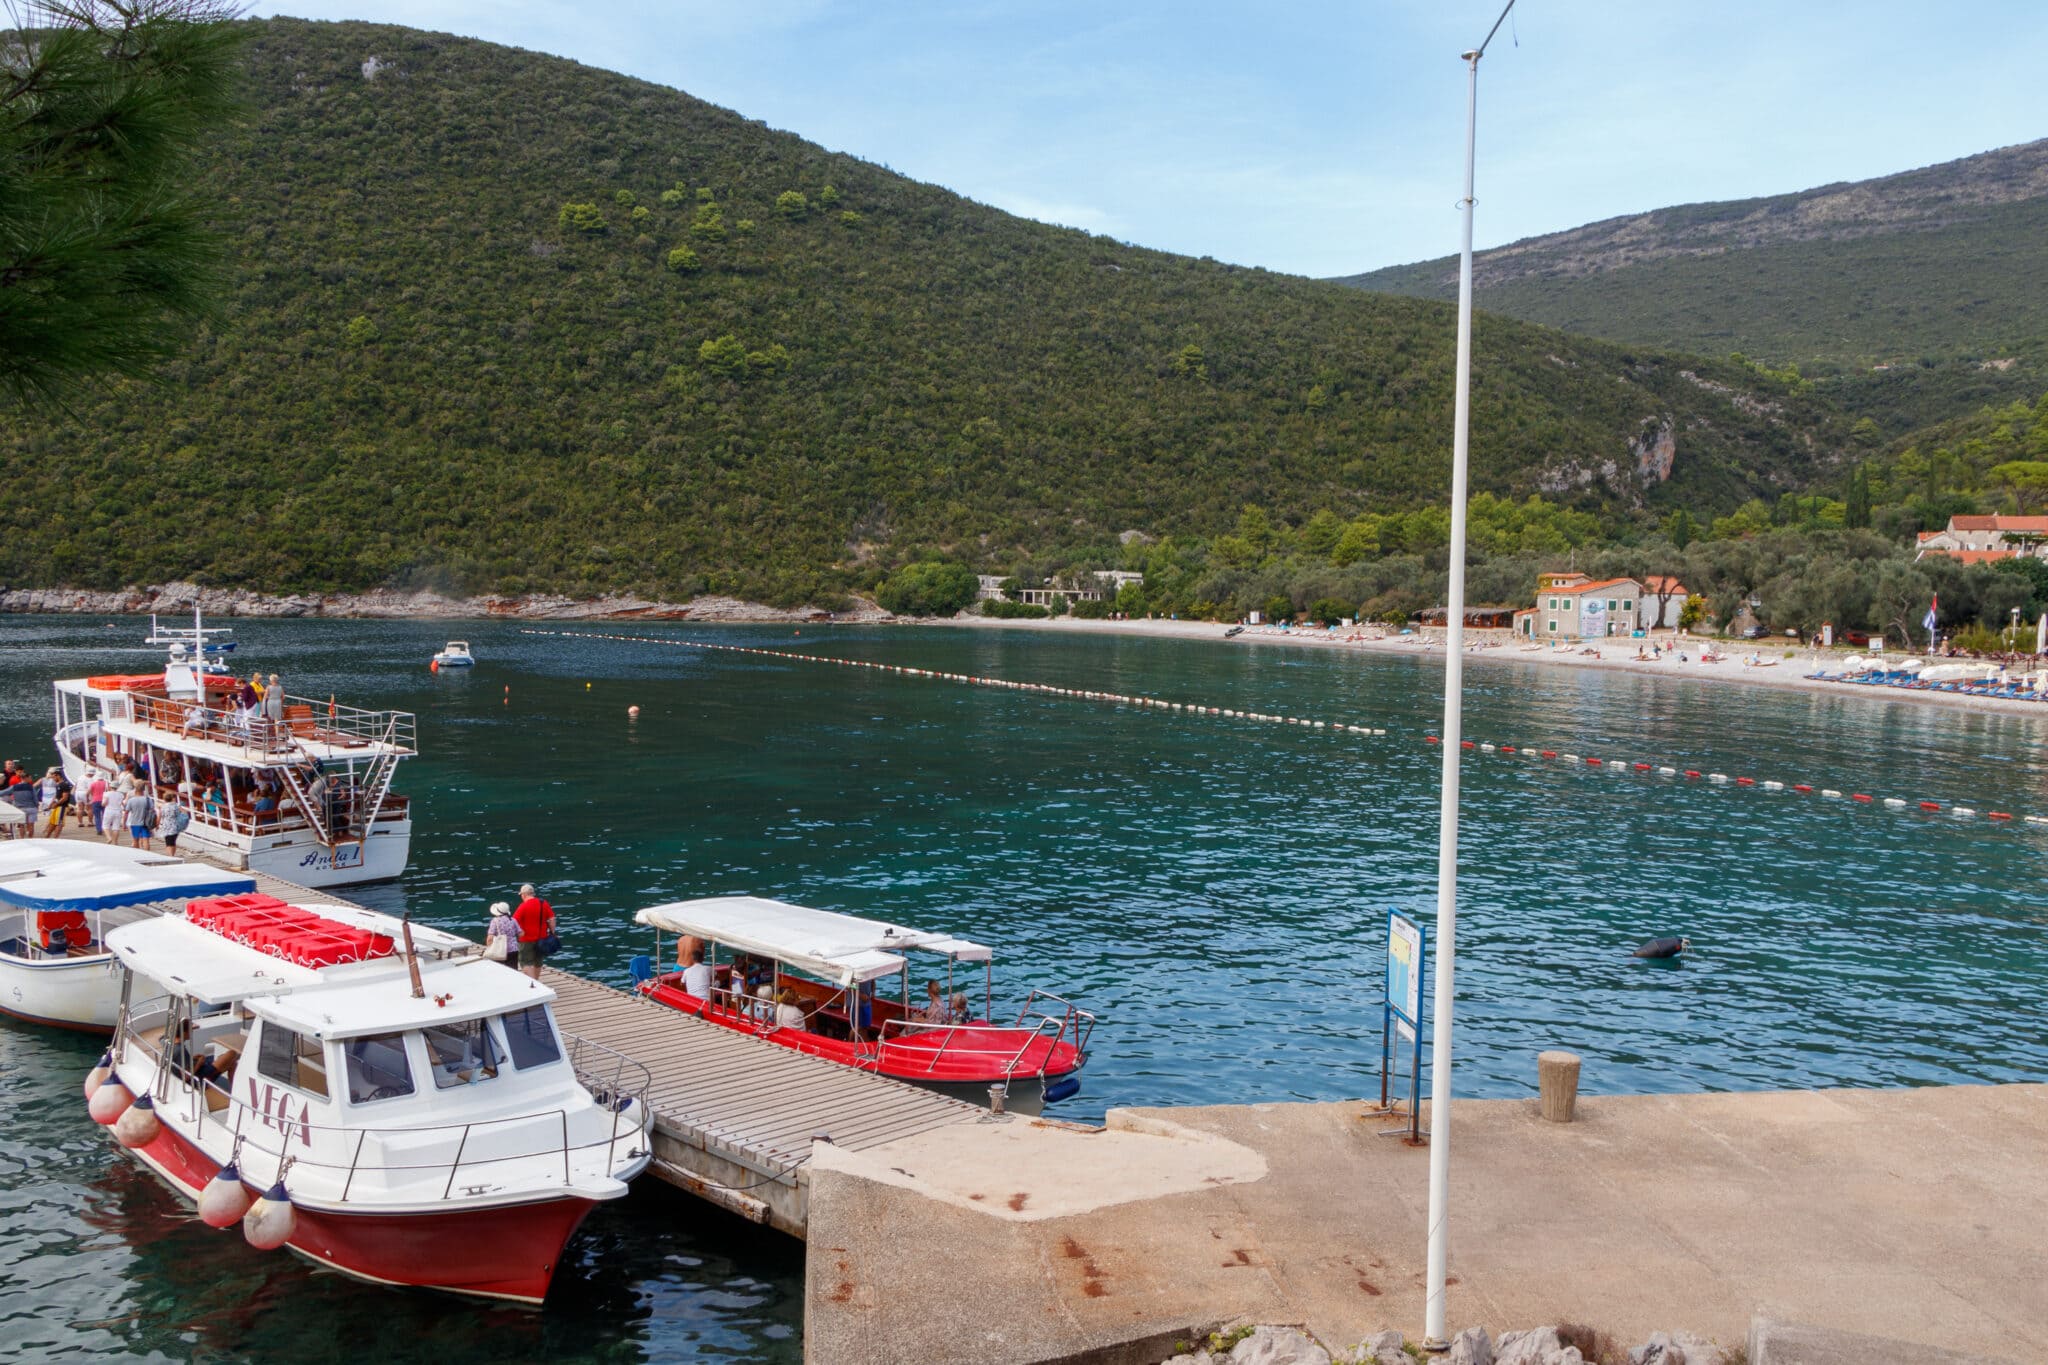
1421, 0, 1516, 1351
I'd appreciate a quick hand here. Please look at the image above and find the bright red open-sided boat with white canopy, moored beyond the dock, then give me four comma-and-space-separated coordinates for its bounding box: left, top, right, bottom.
633, 896, 1096, 1113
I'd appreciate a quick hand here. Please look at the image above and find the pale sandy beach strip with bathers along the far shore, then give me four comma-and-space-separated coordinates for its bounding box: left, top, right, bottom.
950, 614, 2048, 718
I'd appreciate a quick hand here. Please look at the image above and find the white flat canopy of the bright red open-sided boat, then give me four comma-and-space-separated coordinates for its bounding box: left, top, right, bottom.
633, 896, 991, 986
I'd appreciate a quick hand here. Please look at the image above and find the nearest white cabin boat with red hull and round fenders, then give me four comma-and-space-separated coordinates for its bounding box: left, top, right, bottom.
86, 894, 651, 1304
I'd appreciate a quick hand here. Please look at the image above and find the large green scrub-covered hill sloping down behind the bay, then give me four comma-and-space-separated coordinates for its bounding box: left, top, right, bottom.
0, 20, 1843, 600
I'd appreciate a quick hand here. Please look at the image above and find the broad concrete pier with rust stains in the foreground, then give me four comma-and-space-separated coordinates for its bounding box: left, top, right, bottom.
805, 1085, 2048, 1365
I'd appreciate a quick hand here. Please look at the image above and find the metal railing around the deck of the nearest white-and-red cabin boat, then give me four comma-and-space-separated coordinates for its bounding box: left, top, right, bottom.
117, 997, 651, 1203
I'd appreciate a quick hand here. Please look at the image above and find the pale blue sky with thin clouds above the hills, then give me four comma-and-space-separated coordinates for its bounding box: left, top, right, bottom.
254, 0, 2048, 274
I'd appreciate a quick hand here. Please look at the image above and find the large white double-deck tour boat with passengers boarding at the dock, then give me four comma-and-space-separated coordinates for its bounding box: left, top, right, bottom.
57, 614, 418, 886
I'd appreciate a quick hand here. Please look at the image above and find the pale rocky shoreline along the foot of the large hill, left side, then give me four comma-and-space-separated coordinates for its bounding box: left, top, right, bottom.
0, 583, 897, 624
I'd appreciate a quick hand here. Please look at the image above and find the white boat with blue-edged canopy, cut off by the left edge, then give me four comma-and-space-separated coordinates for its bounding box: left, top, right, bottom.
0, 839, 256, 1033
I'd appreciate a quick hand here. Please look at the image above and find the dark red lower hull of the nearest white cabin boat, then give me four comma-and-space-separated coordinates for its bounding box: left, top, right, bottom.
117, 1126, 596, 1304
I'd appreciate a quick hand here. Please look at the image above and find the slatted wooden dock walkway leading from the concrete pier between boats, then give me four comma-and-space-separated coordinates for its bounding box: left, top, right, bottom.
66, 829, 999, 1238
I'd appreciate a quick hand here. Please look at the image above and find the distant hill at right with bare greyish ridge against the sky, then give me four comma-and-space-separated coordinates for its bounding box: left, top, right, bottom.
1341, 141, 2048, 432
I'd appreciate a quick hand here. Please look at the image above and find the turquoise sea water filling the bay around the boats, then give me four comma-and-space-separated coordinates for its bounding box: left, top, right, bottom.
0, 618, 2048, 1361
